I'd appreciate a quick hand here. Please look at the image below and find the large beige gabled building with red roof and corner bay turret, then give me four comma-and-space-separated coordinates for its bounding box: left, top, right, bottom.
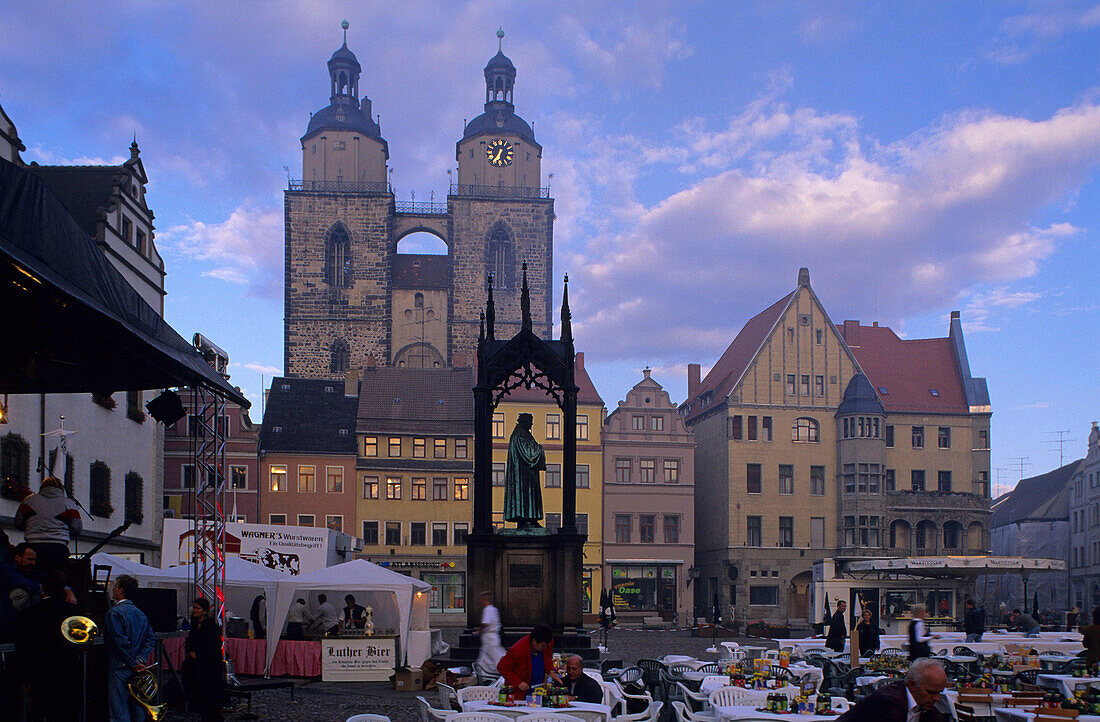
680, 269, 991, 626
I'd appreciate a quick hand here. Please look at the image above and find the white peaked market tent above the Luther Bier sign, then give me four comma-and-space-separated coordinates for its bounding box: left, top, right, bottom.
267, 559, 431, 671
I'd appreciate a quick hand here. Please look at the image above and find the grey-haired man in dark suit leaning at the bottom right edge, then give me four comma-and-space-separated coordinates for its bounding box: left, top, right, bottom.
837, 657, 947, 722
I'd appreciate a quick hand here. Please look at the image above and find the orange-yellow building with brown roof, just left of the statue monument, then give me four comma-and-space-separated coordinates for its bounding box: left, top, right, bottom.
349, 368, 474, 624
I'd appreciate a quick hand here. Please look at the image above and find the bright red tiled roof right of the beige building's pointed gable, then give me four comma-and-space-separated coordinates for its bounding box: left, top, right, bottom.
836, 324, 970, 414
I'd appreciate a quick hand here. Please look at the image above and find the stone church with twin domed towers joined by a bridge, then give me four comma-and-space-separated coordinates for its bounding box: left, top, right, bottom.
284, 33, 554, 379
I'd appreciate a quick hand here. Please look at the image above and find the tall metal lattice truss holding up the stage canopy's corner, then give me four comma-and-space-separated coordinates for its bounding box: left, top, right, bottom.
187, 386, 229, 621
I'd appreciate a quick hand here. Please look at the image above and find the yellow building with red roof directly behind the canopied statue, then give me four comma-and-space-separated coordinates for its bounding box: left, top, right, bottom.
493, 353, 604, 614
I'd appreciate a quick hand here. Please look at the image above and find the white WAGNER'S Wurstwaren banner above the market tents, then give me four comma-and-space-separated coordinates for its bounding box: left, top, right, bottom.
161, 518, 332, 575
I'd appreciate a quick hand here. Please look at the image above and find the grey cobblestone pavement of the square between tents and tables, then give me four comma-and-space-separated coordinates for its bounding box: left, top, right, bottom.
168, 628, 777, 722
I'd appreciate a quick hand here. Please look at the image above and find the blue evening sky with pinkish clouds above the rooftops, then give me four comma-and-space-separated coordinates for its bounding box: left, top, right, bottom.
0, 0, 1100, 497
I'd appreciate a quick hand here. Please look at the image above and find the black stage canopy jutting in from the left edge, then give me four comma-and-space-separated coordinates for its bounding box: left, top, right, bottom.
0, 161, 251, 407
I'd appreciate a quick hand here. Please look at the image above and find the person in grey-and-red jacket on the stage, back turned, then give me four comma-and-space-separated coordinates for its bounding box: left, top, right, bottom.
14, 477, 84, 573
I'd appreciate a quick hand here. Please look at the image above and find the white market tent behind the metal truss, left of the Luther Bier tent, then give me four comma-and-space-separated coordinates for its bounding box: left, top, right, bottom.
91, 551, 289, 627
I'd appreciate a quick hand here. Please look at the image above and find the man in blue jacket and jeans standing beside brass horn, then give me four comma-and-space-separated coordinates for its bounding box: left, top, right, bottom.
103, 575, 153, 722
